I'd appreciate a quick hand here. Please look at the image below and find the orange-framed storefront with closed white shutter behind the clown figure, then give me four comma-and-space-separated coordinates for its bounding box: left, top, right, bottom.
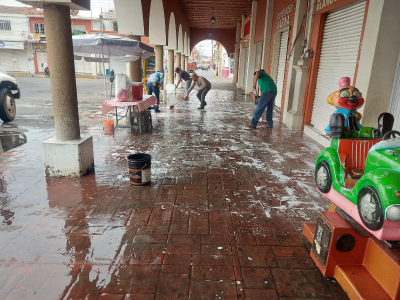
304, 0, 368, 136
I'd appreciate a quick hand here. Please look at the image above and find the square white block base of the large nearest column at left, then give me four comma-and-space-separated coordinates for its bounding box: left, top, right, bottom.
43, 136, 94, 177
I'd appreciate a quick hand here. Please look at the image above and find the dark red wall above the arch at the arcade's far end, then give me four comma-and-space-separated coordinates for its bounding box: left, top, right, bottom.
190, 28, 236, 55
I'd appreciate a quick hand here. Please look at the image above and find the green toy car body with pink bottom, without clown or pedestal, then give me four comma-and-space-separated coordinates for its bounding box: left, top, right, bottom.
315, 127, 400, 232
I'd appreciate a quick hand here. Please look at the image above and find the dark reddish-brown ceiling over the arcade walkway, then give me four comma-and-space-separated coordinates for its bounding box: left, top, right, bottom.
179, 0, 253, 29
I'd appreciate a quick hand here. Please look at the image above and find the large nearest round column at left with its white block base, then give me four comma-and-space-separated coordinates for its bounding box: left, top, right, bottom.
43, 4, 94, 177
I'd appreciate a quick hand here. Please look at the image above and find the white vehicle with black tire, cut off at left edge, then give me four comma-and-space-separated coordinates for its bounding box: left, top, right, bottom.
0, 67, 21, 123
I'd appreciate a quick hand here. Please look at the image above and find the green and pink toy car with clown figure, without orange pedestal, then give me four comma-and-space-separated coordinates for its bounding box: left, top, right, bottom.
315, 78, 400, 241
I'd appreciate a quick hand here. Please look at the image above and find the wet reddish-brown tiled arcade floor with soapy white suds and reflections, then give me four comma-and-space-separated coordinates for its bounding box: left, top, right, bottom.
0, 78, 347, 300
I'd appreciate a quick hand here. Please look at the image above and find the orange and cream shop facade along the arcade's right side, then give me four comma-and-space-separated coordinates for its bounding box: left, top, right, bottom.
234, 0, 400, 145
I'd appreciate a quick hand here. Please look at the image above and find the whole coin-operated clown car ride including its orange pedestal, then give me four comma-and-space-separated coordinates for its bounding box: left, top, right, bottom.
303, 78, 400, 299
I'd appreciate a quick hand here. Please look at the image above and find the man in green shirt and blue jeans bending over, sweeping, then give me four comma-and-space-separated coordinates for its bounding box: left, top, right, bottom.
245, 70, 277, 129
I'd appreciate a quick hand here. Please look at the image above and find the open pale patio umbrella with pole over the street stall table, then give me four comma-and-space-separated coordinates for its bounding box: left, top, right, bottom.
72, 33, 154, 99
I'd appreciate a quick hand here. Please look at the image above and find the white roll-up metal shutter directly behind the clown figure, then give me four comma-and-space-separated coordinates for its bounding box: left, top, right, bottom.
311, 1, 365, 131
